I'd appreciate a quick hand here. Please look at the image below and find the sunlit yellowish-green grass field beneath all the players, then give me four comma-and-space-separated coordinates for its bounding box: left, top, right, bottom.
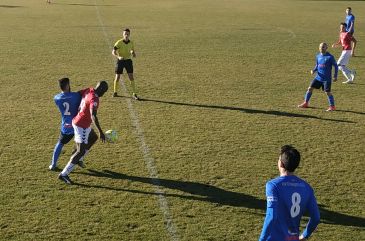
0, 0, 365, 241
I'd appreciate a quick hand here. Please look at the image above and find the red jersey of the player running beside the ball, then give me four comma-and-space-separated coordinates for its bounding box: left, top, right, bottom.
72, 88, 99, 128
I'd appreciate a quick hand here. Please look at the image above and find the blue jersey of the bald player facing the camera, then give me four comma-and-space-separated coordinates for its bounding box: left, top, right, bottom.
313, 52, 338, 82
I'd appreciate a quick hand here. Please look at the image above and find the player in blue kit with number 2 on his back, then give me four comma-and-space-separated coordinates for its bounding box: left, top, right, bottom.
49, 78, 81, 171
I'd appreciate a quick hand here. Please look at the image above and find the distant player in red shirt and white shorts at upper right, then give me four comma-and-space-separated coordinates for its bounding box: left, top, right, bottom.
332, 23, 356, 84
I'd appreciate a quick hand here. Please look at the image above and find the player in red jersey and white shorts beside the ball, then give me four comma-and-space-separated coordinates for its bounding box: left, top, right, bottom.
58, 81, 108, 184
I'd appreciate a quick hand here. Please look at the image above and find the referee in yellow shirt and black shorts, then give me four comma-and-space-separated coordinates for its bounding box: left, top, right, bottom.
112, 28, 139, 100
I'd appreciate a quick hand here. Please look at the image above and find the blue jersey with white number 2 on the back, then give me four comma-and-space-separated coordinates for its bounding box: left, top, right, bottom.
54, 92, 81, 135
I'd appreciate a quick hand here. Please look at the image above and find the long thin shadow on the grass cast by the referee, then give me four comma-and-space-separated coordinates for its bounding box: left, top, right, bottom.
141, 98, 356, 123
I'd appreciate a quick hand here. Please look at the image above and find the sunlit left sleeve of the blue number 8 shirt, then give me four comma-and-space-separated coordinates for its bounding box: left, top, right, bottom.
259, 182, 278, 241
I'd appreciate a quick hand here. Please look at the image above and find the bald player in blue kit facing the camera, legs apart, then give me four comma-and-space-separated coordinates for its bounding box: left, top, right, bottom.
298, 43, 338, 111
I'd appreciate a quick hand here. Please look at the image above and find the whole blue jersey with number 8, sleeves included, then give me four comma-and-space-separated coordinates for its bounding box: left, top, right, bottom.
259, 175, 319, 241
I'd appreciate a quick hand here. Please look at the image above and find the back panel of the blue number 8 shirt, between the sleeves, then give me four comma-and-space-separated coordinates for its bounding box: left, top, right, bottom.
270, 175, 314, 240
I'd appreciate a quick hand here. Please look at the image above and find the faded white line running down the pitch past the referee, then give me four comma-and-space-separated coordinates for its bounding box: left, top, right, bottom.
95, 0, 180, 241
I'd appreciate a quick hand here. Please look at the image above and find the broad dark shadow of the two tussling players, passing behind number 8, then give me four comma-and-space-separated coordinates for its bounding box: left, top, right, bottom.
75, 169, 365, 227
